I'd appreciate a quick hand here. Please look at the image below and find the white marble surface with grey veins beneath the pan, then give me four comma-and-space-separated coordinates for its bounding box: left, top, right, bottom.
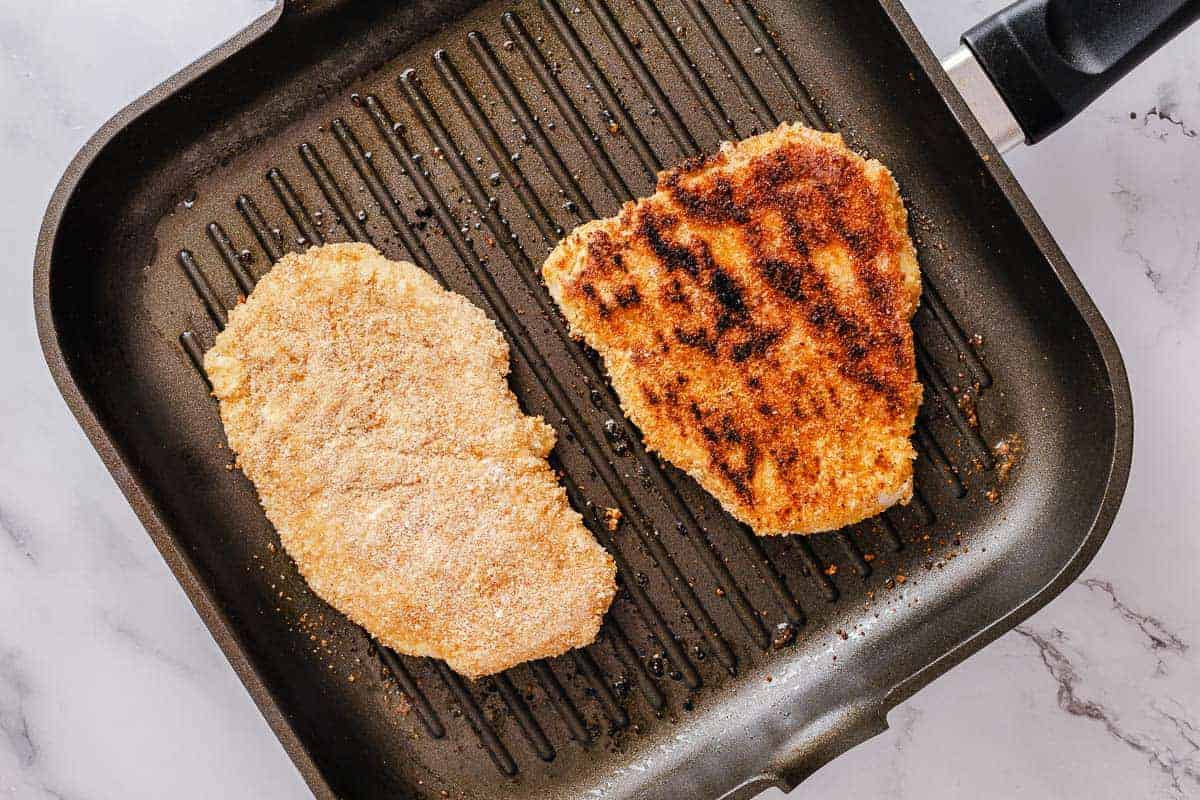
0, 0, 1200, 800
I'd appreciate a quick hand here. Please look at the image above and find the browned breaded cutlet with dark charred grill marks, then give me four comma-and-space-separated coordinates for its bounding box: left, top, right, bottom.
542, 125, 920, 534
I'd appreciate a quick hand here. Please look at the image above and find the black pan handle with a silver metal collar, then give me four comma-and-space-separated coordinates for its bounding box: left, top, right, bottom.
942, 0, 1200, 151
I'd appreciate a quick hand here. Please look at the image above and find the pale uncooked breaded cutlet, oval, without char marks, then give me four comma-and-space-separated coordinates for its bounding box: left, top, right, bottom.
204, 245, 616, 678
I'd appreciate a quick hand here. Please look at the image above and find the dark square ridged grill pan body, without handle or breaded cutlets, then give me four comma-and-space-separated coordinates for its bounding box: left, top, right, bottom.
28, 0, 1132, 800
